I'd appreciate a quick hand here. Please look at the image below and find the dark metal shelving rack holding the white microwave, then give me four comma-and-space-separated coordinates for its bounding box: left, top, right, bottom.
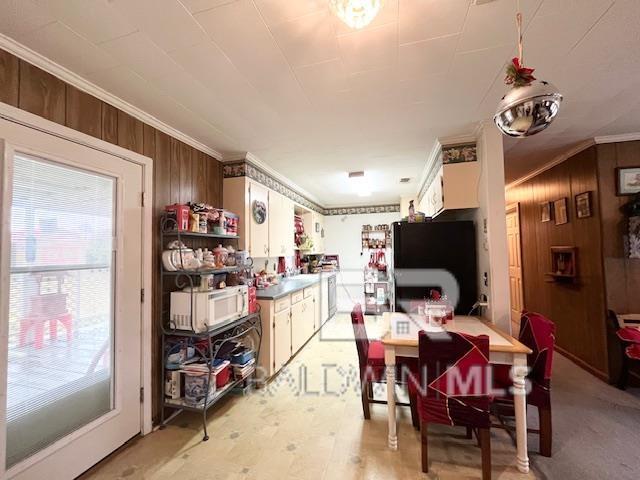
160, 216, 262, 441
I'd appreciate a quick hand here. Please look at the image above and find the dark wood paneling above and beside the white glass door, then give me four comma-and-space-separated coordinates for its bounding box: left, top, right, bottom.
0, 50, 222, 418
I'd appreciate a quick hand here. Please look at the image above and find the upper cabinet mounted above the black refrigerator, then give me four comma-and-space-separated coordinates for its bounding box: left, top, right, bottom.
418, 149, 480, 217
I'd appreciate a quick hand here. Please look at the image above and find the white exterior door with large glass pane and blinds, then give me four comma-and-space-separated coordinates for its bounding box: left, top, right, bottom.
0, 120, 143, 480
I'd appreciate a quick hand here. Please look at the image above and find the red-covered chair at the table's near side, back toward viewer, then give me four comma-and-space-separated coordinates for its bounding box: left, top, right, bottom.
409, 332, 491, 480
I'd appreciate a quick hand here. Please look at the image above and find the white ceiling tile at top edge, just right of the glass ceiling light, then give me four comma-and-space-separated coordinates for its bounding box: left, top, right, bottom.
399, 0, 471, 44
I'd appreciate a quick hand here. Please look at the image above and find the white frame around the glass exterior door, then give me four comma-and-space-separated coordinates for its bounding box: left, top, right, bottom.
0, 102, 153, 468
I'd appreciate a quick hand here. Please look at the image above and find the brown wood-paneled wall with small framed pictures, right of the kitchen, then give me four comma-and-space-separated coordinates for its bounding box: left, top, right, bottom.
507, 147, 608, 378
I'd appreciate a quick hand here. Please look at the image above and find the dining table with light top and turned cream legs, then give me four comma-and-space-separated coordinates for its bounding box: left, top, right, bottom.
381, 312, 532, 473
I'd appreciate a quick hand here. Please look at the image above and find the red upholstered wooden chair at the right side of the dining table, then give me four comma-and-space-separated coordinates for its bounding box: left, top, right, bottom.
493, 311, 556, 457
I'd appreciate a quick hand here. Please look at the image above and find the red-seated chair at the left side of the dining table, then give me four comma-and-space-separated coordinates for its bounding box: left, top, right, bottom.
351, 303, 417, 423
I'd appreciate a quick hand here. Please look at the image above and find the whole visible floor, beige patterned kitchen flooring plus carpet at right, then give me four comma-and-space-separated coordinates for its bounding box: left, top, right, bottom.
82, 315, 640, 480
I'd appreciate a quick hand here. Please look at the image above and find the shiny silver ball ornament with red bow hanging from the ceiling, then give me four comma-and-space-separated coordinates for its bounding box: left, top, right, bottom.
493, 0, 562, 138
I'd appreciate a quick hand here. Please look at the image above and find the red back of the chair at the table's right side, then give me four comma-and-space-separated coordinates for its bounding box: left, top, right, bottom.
519, 312, 556, 387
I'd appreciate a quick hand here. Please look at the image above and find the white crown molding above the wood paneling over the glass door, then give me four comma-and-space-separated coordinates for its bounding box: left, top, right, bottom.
0, 33, 222, 160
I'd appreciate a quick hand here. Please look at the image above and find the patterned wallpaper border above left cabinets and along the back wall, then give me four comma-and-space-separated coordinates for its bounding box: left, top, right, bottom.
222, 160, 400, 215
